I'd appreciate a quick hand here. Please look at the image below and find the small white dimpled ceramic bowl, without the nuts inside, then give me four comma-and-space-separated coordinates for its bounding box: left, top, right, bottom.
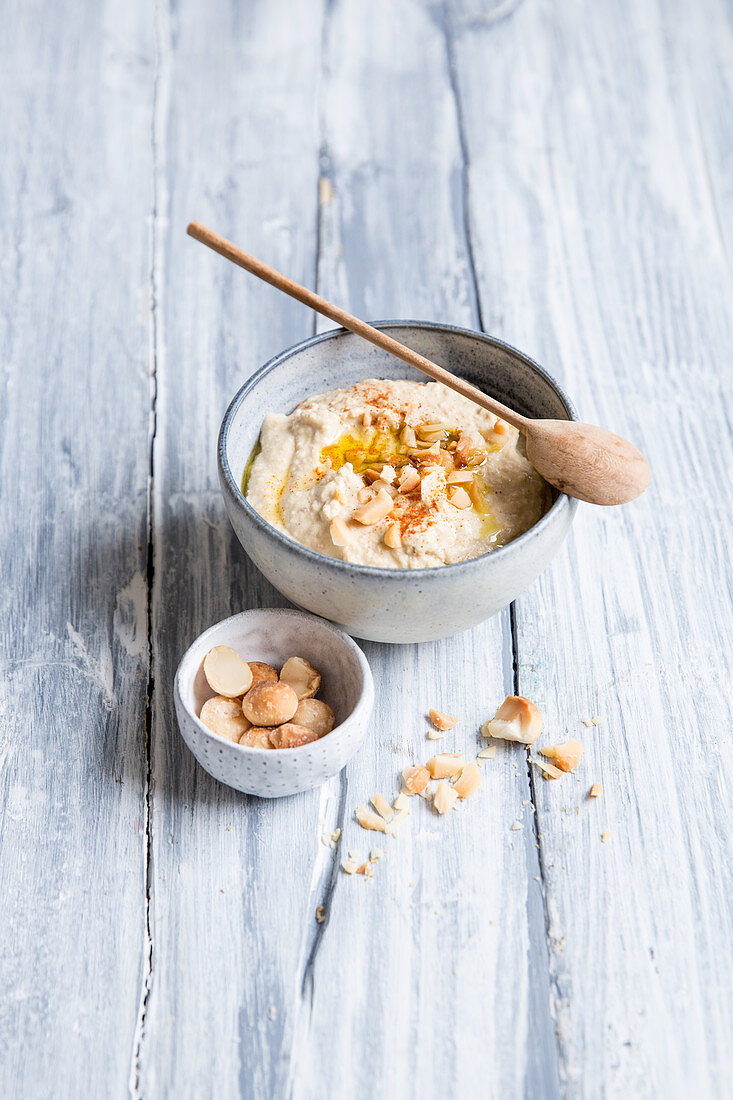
174, 608, 374, 799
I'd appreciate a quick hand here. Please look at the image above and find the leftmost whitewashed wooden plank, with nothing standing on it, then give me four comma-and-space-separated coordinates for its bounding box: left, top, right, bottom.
0, 0, 152, 1097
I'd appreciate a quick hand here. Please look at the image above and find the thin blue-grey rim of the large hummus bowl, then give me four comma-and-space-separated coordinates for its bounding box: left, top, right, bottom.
217, 320, 578, 576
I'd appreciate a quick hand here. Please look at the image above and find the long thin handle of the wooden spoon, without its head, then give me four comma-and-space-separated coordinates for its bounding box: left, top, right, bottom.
186, 221, 530, 431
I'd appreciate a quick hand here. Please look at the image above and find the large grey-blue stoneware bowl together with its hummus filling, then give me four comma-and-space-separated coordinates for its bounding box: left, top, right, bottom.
218, 321, 577, 642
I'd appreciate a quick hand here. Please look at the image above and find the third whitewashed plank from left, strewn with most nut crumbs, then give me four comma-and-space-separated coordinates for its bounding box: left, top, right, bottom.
291, 2, 556, 1098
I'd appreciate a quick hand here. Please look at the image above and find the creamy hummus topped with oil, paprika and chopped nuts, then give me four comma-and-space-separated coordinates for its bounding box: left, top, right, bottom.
242, 380, 551, 569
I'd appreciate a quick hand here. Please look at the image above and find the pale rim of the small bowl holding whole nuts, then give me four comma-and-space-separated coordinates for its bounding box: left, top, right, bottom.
173, 607, 374, 763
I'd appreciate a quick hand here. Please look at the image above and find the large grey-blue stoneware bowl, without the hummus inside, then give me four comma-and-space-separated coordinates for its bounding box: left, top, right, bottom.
219, 321, 578, 642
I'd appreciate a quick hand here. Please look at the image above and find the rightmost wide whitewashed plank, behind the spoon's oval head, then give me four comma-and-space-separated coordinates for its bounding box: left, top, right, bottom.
452, 2, 731, 1096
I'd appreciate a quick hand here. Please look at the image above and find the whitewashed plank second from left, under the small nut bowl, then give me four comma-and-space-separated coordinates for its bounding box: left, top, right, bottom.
138, 0, 325, 1100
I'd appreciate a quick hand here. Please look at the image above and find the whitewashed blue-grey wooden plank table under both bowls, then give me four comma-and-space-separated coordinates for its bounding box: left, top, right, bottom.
0, 0, 733, 1100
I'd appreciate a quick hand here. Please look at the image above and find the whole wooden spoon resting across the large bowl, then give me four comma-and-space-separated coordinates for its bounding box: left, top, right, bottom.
187, 221, 650, 504
